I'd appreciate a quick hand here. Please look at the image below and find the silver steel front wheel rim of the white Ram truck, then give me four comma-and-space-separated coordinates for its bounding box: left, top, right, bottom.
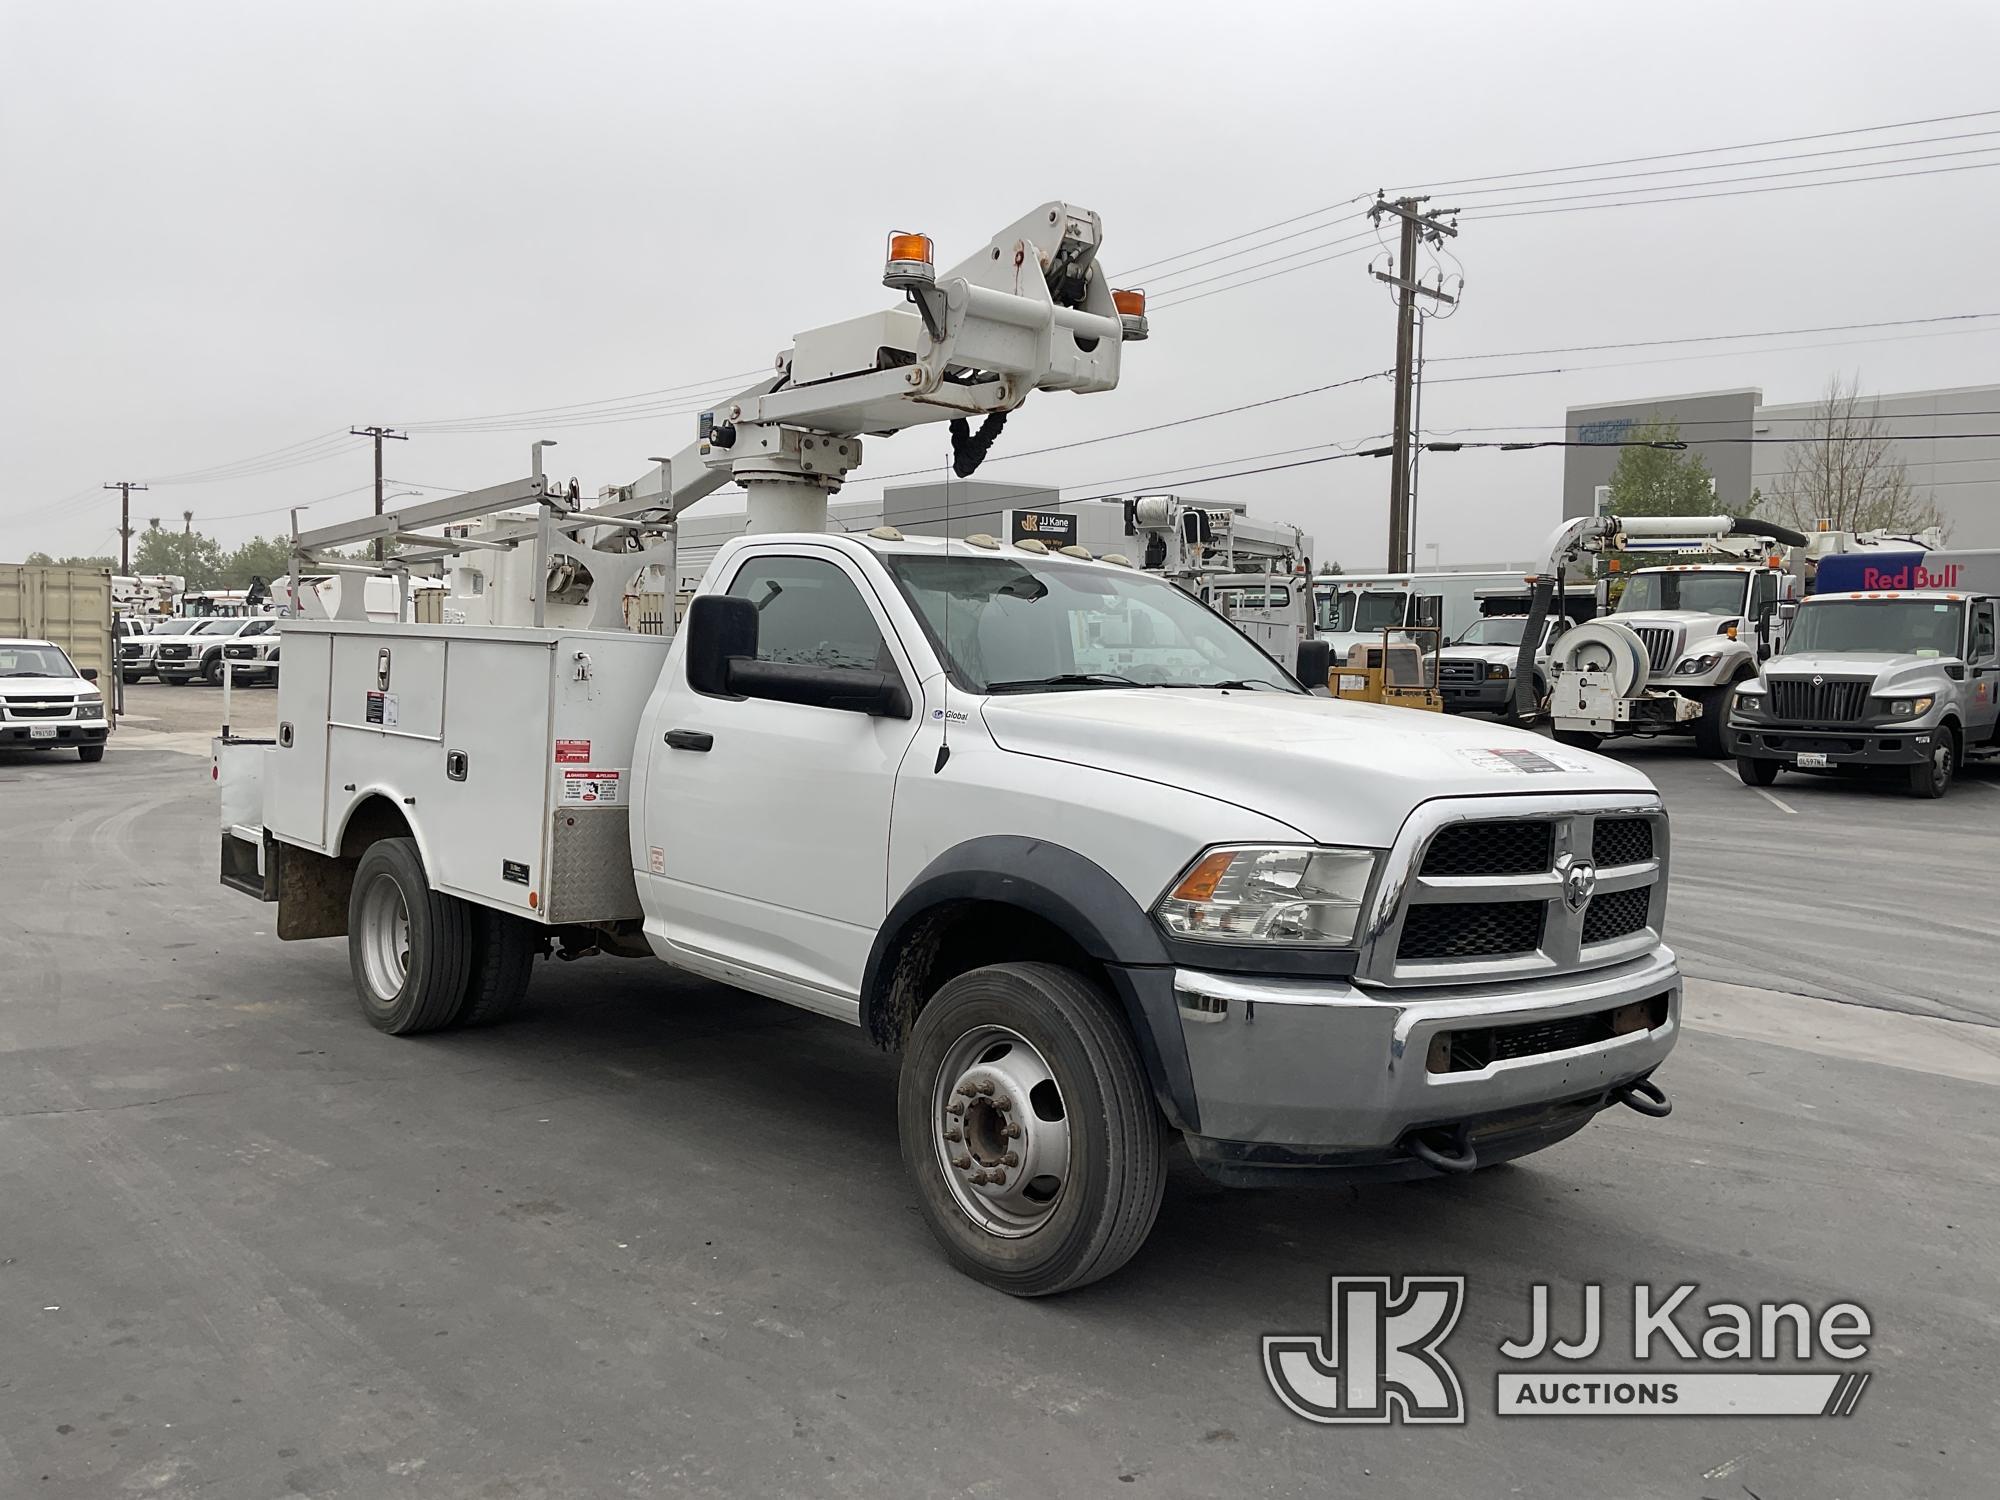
930, 1026, 1072, 1240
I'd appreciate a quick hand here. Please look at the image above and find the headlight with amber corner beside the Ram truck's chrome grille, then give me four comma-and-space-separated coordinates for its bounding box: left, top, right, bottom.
1154, 848, 1376, 948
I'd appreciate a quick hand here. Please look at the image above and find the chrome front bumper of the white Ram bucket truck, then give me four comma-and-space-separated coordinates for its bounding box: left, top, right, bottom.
1174, 946, 1680, 1182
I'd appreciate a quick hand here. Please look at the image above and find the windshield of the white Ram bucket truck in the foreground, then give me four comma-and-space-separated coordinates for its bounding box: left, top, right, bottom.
884, 554, 1300, 692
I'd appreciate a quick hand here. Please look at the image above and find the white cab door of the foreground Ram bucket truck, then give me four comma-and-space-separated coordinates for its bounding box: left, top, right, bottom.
638, 542, 920, 1018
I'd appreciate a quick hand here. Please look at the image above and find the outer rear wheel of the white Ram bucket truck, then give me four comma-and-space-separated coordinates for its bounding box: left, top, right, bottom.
348, 838, 472, 1036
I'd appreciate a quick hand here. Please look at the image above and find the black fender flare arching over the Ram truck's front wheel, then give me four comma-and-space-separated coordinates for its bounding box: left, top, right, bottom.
860, 834, 1198, 1130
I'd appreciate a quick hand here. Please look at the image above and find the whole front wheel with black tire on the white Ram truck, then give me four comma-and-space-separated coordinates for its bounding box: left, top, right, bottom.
896, 964, 1166, 1296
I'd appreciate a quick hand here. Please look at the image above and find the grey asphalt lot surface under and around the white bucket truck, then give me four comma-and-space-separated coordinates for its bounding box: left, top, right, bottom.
0, 700, 2000, 1500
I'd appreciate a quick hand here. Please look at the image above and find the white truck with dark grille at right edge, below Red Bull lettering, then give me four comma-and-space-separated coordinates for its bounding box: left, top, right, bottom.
1730, 590, 2000, 798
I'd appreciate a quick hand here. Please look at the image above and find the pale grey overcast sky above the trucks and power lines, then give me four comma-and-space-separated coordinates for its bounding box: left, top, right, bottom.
0, 0, 2000, 568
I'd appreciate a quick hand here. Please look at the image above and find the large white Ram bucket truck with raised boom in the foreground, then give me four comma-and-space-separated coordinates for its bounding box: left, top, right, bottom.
216, 204, 1680, 1296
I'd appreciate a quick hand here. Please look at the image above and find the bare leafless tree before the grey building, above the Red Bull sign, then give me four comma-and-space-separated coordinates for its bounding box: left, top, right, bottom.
1768, 374, 1950, 532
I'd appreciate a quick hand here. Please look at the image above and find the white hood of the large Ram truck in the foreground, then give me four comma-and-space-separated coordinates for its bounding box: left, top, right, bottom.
980, 688, 1654, 848
